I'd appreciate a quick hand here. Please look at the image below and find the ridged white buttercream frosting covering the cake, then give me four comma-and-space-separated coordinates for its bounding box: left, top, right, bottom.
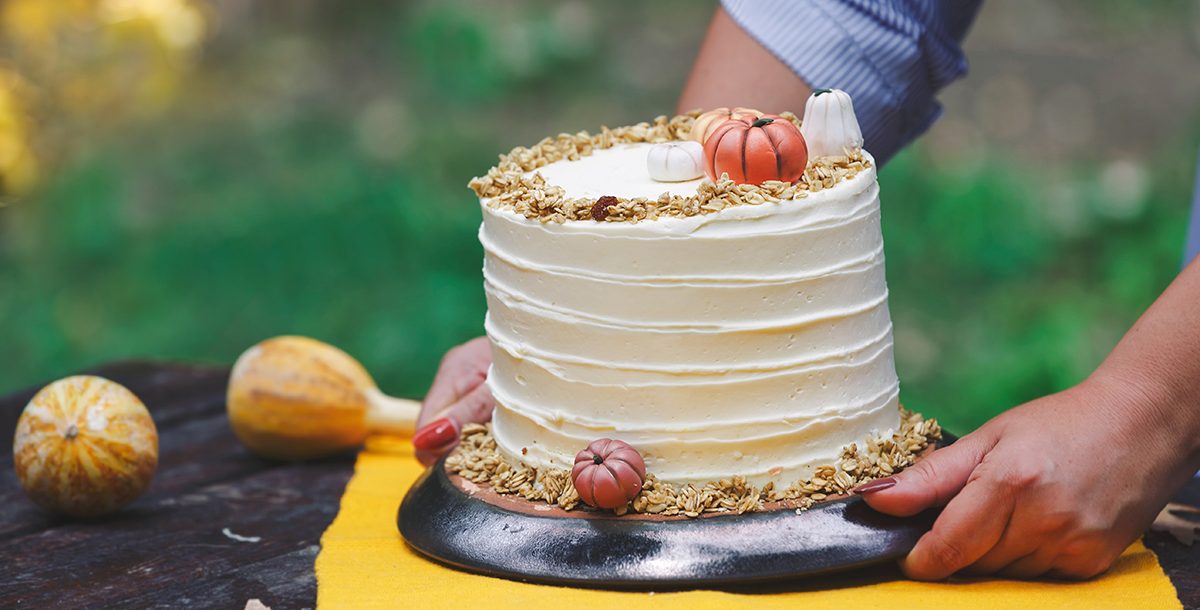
479, 144, 899, 486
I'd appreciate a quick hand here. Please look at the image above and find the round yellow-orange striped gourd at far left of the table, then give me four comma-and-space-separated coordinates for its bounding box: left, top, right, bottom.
12, 376, 158, 516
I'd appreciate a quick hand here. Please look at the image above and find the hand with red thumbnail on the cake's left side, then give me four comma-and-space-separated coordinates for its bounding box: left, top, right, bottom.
413, 336, 496, 465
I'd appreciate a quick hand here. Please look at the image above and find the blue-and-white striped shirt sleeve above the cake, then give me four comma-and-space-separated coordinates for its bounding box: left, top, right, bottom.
721, 0, 982, 165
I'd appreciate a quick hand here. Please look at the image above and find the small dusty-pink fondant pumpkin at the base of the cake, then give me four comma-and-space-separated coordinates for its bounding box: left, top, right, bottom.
571, 438, 646, 508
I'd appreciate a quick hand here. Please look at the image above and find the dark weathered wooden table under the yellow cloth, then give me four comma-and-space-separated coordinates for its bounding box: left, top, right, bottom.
0, 361, 1200, 610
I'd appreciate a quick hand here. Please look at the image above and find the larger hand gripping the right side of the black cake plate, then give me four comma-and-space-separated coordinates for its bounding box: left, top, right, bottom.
857, 376, 1195, 580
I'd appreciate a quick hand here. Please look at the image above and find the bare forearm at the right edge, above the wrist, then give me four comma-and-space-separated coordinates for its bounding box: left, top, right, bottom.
1088, 261, 1200, 463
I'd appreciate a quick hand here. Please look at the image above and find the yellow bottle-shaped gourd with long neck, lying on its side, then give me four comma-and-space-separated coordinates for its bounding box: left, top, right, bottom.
226, 336, 420, 460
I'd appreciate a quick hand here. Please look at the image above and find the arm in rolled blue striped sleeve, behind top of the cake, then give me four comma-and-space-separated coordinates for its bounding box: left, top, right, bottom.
678, 0, 980, 166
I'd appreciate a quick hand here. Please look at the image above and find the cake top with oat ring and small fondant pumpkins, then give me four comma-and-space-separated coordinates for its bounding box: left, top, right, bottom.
469, 90, 871, 223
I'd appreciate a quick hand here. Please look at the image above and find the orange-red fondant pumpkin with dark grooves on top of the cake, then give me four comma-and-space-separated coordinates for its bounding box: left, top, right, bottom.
704, 115, 809, 185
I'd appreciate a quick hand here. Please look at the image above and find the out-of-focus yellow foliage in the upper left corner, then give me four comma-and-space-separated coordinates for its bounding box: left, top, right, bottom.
0, 0, 208, 198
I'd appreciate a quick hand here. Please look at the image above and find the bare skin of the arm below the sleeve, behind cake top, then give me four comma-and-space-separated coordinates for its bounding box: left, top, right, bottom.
678, 7, 811, 114
